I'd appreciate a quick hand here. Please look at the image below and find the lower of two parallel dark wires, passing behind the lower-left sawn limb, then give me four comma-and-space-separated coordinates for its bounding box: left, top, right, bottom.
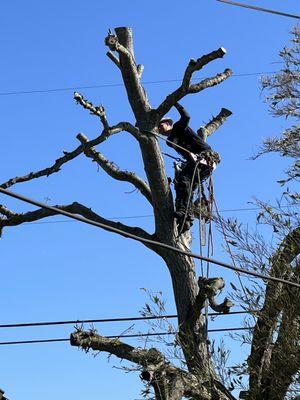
0, 327, 253, 346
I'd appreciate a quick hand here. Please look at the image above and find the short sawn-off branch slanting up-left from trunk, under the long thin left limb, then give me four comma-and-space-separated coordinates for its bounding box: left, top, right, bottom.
77, 134, 152, 204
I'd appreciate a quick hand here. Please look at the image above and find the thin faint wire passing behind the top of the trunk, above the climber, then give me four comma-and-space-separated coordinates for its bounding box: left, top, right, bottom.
0, 71, 275, 96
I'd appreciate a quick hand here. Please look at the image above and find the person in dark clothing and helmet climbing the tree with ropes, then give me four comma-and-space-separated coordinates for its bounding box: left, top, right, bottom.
159, 103, 220, 232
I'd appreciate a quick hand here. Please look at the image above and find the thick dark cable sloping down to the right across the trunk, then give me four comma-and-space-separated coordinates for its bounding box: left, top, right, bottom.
0, 187, 300, 288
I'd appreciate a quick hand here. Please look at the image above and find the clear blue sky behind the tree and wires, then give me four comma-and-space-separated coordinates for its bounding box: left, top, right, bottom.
0, 0, 299, 400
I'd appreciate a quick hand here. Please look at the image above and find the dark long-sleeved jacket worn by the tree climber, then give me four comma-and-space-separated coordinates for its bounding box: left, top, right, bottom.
167, 103, 211, 161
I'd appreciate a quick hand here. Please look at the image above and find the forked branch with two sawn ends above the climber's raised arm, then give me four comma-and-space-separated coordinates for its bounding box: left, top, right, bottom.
157, 47, 232, 118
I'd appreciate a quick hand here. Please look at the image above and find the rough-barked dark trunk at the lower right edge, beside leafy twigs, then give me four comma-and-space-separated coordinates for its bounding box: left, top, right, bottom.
248, 228, 300, 400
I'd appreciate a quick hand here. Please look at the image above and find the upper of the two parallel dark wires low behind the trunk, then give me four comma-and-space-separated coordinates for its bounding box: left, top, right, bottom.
0, 311, 251, 328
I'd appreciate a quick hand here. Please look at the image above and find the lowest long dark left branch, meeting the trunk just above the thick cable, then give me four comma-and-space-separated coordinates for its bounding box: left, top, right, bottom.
0, 202, 152, 241
